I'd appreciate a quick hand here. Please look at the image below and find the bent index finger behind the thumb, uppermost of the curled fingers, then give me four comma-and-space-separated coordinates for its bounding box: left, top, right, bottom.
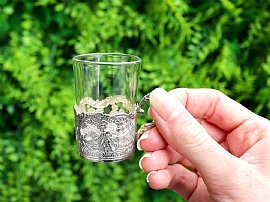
170, 88, 253, 131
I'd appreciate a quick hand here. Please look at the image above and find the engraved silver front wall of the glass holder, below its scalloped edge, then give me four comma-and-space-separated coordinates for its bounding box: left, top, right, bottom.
74, 105, 136, 162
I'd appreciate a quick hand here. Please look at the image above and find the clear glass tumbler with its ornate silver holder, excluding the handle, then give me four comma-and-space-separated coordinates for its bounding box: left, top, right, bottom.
73, 53, 141, 162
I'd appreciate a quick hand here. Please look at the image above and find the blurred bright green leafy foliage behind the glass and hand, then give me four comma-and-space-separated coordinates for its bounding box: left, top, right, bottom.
0, 0, 270, 202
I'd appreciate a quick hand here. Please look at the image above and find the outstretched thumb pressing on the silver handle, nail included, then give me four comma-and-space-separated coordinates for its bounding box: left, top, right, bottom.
150, 88, 233, 177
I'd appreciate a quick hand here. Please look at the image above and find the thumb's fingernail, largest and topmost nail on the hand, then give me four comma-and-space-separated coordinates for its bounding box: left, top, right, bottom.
150, 88, 180, 121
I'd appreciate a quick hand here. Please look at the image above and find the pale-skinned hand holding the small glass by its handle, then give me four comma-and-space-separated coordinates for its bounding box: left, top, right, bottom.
137, 88, 270, 202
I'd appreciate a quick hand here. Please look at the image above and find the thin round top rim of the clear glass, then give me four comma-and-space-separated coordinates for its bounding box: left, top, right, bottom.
72, 53, 142, 65
